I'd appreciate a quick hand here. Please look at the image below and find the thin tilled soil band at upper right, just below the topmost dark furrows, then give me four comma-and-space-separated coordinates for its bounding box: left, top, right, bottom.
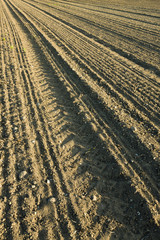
24, 1, 159, 50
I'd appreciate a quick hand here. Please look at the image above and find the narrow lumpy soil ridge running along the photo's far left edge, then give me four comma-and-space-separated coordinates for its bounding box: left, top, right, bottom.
1, 10, 20, 239
